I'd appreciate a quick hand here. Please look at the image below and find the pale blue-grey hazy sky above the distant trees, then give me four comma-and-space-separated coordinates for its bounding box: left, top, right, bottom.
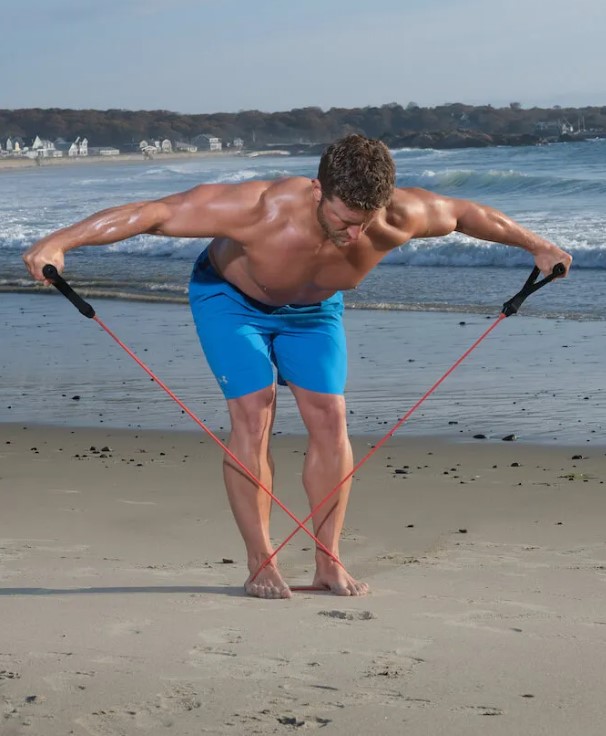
0, 0, 606, 113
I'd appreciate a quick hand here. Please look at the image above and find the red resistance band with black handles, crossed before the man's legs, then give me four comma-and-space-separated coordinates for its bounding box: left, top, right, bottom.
43, 263, 565, 590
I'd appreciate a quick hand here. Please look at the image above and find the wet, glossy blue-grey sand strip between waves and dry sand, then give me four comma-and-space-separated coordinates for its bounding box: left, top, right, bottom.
0, 294, 606, 447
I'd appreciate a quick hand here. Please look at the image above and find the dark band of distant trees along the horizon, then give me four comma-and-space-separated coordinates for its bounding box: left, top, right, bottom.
0, 102, 606, 149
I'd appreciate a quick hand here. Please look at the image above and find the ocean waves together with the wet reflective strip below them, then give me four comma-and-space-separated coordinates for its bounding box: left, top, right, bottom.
0, 140, 606, 445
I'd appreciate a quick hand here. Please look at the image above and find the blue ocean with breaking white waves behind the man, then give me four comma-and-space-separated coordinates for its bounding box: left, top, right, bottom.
0, 140, 606, 320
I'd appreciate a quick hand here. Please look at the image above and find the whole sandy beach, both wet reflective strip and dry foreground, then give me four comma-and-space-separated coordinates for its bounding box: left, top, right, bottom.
0, 294, 606, 736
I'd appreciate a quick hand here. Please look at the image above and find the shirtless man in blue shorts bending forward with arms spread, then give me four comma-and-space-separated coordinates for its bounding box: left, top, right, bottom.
24, 135, 572, 598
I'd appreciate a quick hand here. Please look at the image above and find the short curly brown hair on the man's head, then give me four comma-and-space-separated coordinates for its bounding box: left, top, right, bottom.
318, 133, 396, 211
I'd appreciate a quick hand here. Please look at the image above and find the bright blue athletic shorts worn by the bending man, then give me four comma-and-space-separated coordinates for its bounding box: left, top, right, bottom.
189, 250, 347, 399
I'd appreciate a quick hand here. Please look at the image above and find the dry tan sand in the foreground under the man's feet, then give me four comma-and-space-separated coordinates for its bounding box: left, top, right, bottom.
0, 424, 606, 736
